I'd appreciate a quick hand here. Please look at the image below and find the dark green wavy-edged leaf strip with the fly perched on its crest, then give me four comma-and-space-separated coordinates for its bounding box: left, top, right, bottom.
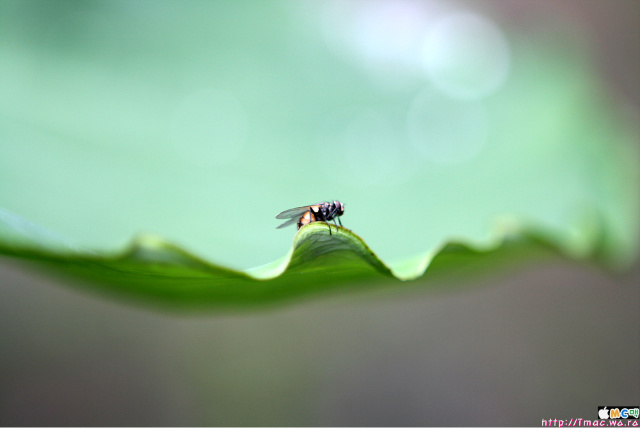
0, 206, 628, 310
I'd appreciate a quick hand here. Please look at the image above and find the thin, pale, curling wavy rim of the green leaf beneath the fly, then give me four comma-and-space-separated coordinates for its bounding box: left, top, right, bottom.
0, 211, 635, 281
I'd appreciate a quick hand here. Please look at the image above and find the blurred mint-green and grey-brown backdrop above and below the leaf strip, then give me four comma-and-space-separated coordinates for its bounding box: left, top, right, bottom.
0, 0, 640, 425
